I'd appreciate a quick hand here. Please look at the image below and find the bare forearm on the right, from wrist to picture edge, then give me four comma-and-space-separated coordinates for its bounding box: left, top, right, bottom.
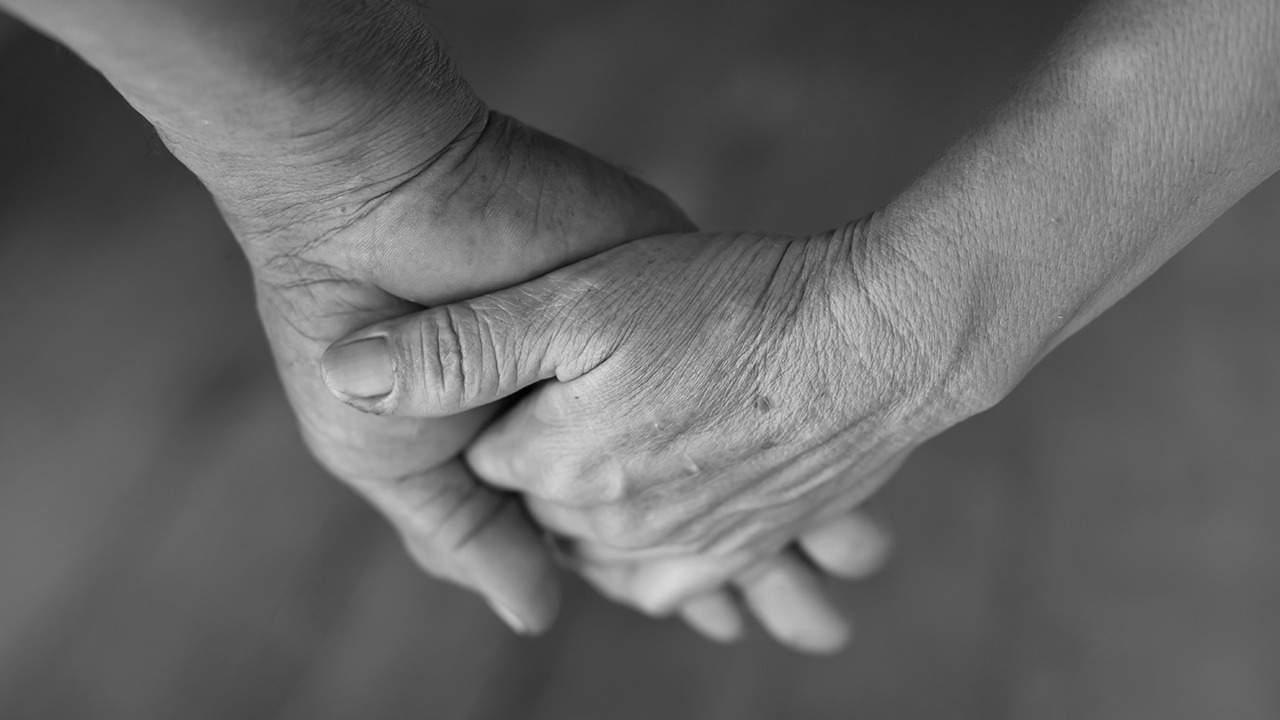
870, 0, 1280, 407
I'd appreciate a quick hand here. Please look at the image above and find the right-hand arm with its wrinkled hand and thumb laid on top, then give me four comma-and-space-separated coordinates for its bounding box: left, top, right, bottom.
326, 0, 1280, 609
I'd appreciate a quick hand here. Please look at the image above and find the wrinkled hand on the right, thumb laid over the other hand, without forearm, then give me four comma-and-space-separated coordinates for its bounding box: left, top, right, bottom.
325, 225, 954, 645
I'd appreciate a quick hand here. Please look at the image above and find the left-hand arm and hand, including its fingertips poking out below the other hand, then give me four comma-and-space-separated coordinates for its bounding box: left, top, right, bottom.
0, 0, 886, 650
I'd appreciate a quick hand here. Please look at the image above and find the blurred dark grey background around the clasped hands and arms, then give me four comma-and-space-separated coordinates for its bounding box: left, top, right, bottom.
0, 0, 1280, 720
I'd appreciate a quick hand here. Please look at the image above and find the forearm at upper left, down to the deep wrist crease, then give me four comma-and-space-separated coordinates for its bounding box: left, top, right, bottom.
0, 0, 480, 212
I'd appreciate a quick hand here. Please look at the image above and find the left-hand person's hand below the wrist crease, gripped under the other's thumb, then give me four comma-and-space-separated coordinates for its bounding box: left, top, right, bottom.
229, 106, 706, 633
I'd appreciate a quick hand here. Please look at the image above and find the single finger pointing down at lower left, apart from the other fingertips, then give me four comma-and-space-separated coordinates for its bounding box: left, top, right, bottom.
360, 460, 559, 634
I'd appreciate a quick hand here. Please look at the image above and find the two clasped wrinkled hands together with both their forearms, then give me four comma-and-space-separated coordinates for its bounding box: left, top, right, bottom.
17, 0, 1280, 651
